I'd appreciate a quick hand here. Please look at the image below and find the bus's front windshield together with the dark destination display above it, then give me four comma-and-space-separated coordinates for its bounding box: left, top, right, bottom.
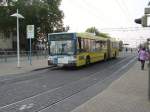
48, 33, 75, 55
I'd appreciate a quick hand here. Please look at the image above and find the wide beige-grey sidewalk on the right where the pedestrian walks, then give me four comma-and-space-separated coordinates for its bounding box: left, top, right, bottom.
71, 62, 150, 112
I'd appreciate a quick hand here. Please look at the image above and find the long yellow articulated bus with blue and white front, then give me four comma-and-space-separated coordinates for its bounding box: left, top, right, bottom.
48, 32, 119, 67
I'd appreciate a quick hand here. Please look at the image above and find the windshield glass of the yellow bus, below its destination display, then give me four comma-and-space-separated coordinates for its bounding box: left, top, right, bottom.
50, 40, 74, 55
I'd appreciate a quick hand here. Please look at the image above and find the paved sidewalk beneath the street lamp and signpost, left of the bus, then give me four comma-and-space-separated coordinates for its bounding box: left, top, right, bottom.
0, 58, 48, 76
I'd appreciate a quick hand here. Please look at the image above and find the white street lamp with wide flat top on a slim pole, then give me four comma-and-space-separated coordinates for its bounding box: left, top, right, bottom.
11, 9, 24, 67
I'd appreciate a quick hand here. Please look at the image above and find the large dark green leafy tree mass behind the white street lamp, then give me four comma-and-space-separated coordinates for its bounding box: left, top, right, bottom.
0, 0, 64, 47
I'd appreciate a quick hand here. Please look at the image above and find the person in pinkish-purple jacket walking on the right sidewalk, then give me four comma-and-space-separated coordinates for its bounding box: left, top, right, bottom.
138, 48, 148, 70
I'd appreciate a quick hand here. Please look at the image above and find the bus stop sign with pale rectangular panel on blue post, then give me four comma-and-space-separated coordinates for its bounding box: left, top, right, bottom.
27, 25, 34, 65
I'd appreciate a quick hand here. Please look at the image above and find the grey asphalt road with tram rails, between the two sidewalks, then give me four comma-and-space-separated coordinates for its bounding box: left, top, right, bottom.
0, 55, 135, 112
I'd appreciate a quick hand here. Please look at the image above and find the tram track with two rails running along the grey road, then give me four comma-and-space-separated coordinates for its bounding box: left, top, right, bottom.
0, 54, 133, 112
